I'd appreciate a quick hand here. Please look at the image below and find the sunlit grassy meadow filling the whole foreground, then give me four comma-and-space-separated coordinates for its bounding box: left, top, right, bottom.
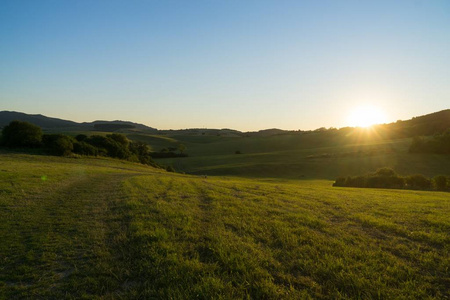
0, 152, 450, 299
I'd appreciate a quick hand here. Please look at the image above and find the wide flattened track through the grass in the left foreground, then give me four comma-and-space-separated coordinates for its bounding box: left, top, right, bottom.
4, 173, 139, 298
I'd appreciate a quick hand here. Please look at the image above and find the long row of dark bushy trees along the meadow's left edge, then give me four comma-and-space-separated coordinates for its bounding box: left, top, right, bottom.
1, 121, 166, 170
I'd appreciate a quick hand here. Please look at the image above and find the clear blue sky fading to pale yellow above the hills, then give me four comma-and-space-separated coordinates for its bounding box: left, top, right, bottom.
0, 0, 450, 131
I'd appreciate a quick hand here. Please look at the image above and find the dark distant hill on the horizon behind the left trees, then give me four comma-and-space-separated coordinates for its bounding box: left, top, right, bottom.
0, 111, 157, 132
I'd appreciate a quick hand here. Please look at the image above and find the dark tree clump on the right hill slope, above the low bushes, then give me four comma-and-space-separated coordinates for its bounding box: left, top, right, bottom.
409, 129, 450, 154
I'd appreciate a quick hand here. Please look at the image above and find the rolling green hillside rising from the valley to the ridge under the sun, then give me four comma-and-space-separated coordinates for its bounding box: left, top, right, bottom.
0, 110, 450, 180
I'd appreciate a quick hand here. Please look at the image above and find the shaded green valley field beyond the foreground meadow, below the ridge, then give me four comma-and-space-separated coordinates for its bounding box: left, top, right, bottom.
129, 133, 450, 180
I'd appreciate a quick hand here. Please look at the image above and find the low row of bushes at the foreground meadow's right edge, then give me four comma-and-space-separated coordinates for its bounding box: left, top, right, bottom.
333, 168, 450, 191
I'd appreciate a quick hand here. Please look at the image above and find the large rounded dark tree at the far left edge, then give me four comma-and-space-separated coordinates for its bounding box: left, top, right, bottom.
2, 121, 42, 147
